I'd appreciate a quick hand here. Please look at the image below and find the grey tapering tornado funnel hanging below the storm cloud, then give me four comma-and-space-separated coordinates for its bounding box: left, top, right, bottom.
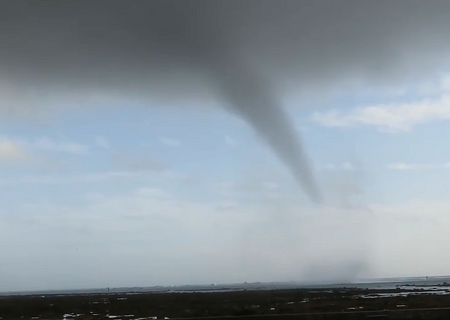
209, 58, 322, 203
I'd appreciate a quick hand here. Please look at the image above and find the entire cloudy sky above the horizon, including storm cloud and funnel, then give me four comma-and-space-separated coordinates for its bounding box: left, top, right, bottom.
0, 0, 450, 291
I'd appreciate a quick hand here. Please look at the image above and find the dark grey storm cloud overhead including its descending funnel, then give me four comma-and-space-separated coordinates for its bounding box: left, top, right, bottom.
0, 0, 450, 200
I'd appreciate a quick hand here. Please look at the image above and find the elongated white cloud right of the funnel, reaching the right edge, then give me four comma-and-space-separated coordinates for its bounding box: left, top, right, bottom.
311, 94, 450, 132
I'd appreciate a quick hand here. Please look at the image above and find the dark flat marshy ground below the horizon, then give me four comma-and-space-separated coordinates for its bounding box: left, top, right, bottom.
0, 288, 450, 320
